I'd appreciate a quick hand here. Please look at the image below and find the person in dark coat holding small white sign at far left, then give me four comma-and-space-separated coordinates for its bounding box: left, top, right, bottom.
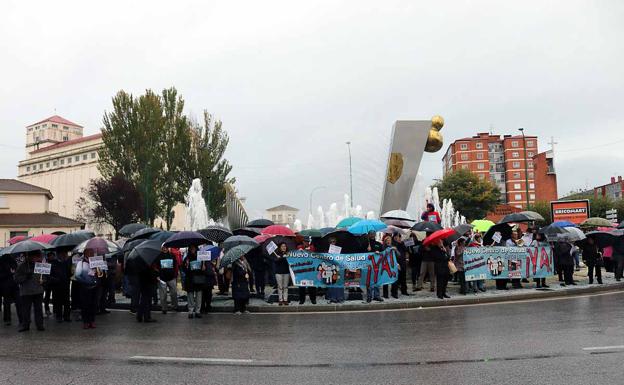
15, 253, 45, 332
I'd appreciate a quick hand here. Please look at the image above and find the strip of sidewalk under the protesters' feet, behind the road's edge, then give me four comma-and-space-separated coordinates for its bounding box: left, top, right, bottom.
112, 268, 624, 313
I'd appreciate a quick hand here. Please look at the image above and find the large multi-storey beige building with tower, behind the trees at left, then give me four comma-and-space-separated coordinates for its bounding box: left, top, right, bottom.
17, 115, 186, 235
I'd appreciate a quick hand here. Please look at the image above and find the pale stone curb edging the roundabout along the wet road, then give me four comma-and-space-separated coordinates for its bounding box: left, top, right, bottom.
111, 282, 624, 313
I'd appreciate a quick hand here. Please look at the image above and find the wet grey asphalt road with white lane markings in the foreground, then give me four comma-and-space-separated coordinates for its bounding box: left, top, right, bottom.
0, 293, 624, 385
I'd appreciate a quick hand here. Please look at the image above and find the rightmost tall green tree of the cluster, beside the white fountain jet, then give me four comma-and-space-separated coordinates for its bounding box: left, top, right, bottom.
193, 111, 236, 219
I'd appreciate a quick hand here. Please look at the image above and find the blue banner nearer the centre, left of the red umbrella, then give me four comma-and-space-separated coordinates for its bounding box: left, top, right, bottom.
286, 249, 399, 287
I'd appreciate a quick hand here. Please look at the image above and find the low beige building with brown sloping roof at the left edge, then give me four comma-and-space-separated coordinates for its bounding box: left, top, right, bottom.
0, 179, 84, 246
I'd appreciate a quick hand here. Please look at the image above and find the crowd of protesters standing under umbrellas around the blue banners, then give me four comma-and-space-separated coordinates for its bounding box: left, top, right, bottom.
0, 210, 624, 332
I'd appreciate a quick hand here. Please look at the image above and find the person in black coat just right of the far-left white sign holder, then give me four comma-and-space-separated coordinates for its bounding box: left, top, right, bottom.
48, 253, 72, 322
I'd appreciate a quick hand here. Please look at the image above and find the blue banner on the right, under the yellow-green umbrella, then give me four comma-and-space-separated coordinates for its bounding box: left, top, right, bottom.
464, 246, 554, 281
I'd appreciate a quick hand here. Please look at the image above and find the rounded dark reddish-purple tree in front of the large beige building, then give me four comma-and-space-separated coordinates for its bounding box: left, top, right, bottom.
76, 175, 143, 239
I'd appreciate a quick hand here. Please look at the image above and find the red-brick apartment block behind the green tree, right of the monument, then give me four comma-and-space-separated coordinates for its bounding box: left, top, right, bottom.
442, 133, 557, 208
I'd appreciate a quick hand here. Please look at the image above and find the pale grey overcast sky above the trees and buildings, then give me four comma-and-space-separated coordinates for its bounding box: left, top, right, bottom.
0, 0, 624, 218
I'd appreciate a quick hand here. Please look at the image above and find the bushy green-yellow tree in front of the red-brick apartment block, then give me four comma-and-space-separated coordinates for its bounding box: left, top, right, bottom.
435, 170, 500, 221
